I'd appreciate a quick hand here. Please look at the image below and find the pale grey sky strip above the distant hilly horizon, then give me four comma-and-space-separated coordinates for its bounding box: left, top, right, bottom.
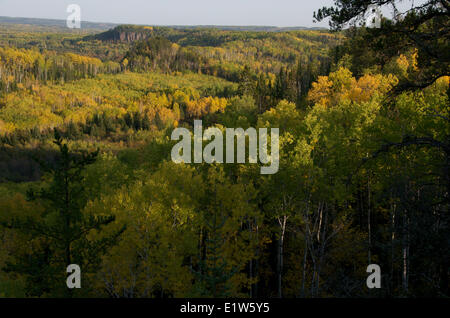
0, 0, 420, 27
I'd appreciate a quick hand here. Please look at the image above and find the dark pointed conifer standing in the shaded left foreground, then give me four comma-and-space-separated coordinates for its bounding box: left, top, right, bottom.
2, 130, 124, 297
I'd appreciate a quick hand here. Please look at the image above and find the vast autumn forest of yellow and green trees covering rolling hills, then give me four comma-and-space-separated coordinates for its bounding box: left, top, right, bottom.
0, 0, 450, 298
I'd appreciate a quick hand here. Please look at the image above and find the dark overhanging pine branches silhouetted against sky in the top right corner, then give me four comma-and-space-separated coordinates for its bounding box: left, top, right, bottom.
314, 0, 450, 91
